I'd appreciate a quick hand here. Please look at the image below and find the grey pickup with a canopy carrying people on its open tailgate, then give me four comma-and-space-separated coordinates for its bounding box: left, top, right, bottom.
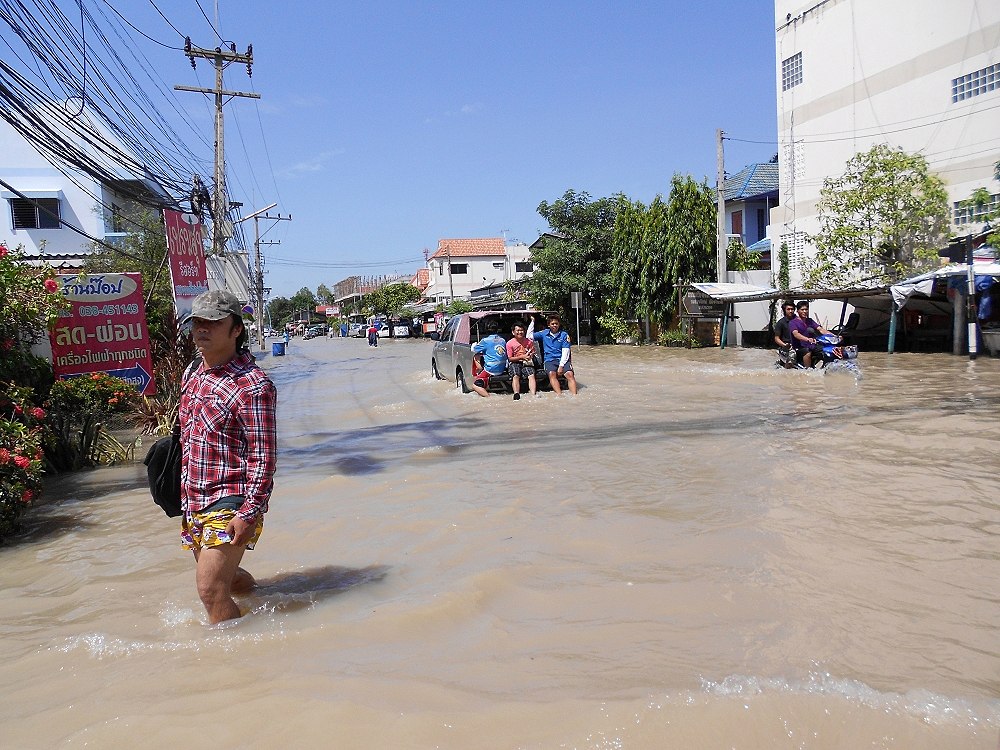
431, 310, 564, 393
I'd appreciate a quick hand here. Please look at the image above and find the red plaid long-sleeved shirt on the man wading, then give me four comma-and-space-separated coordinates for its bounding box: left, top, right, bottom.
180, 350, 277, 522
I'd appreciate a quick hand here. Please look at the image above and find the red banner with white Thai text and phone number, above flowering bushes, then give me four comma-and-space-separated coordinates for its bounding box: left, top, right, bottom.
49, 273, 156, 396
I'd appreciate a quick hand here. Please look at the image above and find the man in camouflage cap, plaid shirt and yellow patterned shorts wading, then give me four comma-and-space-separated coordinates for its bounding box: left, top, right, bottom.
180, 290, 277, 625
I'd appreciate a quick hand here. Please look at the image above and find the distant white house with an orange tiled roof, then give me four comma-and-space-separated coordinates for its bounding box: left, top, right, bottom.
424, 237, 533, 302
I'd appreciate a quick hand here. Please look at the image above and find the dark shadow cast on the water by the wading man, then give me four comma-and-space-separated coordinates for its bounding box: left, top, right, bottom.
245, 565, 390, 612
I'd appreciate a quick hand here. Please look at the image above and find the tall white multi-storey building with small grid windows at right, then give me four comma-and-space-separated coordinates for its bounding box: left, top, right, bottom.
769, 0, 1000, 294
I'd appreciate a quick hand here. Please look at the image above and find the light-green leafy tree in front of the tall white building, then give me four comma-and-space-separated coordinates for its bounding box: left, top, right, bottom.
805, 144, 949, 289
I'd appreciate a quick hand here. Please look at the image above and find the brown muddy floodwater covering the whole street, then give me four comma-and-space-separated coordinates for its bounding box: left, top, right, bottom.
0, 339, 1000, 750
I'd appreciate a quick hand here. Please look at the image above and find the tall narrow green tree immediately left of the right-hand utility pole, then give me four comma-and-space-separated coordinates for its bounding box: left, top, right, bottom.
659, 174, 717, 320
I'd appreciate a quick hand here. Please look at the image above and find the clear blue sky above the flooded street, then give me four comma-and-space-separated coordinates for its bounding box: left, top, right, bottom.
7, 0, 776, 296
